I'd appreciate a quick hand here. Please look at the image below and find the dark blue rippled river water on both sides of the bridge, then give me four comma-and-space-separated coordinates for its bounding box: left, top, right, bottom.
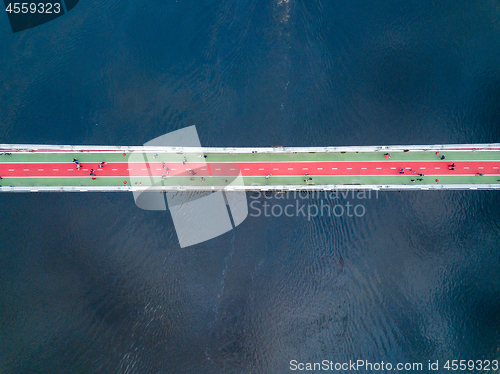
0, 0, 500, 373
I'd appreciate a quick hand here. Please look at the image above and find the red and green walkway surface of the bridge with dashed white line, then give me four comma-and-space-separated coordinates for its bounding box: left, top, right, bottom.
0, 145, 500, 191
